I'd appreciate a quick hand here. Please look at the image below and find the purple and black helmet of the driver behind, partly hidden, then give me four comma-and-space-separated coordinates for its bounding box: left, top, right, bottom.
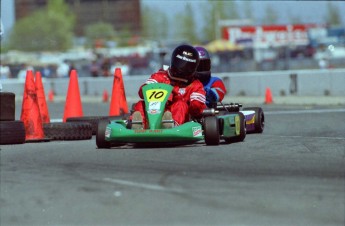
195, 46, 211, 85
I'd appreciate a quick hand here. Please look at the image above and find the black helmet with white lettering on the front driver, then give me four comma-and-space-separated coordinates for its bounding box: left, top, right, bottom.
169, 45, 199, 83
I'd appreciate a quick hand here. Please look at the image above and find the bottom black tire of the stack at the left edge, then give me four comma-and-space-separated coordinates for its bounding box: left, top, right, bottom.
0, 120, 25, 144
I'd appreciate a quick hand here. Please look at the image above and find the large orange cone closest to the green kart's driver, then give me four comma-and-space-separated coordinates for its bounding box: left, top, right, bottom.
109, 68, 128, 116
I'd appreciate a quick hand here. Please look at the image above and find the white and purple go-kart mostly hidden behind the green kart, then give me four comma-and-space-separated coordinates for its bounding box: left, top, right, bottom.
212, 103, 265, 133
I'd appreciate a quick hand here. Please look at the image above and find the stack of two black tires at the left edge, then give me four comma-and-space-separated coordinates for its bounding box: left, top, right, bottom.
0, 92, 25, 144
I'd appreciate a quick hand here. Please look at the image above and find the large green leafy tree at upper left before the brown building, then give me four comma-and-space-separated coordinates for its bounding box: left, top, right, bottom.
9, 0, 75, 51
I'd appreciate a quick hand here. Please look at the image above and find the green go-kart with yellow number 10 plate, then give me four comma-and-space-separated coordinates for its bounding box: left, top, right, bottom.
96, 83, 246, 148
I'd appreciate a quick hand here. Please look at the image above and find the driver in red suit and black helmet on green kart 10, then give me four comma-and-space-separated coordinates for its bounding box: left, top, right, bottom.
132, 44, 206, 129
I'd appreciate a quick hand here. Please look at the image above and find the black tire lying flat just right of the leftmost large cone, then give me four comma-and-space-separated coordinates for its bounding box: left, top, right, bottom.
43, 122, 92, 140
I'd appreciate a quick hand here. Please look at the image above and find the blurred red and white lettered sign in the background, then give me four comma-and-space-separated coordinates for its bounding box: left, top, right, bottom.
223, 24, 316, 47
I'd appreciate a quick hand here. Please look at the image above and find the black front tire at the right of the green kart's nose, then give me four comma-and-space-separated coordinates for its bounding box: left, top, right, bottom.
204, 116, 220, 145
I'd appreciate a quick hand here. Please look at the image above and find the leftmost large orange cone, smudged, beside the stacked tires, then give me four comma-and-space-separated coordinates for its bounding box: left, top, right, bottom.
20, 70, 47, 142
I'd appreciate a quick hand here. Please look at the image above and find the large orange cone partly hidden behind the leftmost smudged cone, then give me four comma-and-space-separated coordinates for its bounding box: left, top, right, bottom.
35, 71, 50, 123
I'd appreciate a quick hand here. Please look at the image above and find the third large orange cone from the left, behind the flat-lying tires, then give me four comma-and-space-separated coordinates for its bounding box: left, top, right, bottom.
63, 70, 83, 122
